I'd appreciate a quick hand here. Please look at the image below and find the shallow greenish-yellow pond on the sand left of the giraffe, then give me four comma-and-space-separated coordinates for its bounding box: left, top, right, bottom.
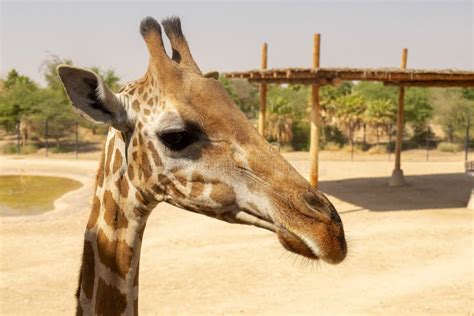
0, 175, 82, 216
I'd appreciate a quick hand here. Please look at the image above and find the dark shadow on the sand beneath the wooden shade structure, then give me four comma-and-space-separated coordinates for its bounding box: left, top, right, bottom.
320, 173, 474, 213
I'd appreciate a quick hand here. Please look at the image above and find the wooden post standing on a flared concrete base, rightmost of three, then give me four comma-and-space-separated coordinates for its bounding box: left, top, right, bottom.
388, 48, 408, 186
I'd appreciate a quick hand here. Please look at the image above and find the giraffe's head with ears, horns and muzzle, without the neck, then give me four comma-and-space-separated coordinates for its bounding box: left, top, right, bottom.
58, 18, 347, 263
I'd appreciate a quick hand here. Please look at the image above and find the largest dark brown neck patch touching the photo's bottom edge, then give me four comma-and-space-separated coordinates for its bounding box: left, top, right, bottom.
95, 278, 127, 316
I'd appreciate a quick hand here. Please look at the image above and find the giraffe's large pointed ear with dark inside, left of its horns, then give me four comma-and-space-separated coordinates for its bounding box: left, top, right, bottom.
57, 65, 130, 131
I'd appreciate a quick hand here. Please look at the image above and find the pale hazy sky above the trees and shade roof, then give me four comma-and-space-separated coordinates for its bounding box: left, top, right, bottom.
0, 0, 474, 83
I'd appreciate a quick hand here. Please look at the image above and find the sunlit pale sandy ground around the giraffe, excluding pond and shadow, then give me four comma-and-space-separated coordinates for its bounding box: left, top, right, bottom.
0, 153, 474, 315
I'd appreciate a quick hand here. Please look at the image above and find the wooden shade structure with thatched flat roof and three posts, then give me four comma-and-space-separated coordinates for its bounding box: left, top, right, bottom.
223, 34, 474, 187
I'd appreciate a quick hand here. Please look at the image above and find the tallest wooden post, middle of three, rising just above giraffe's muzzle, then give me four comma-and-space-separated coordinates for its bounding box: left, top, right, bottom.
309, 34, 321, 188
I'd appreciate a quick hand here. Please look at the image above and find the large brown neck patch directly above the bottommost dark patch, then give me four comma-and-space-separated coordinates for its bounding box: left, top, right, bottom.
97, 229, 133, 280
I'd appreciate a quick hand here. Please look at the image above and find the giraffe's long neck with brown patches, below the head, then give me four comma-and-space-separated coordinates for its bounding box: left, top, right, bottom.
77, 128, 156, 315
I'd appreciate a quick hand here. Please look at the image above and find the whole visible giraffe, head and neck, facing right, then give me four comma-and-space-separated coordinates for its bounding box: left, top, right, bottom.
57, 17, 347, 315
